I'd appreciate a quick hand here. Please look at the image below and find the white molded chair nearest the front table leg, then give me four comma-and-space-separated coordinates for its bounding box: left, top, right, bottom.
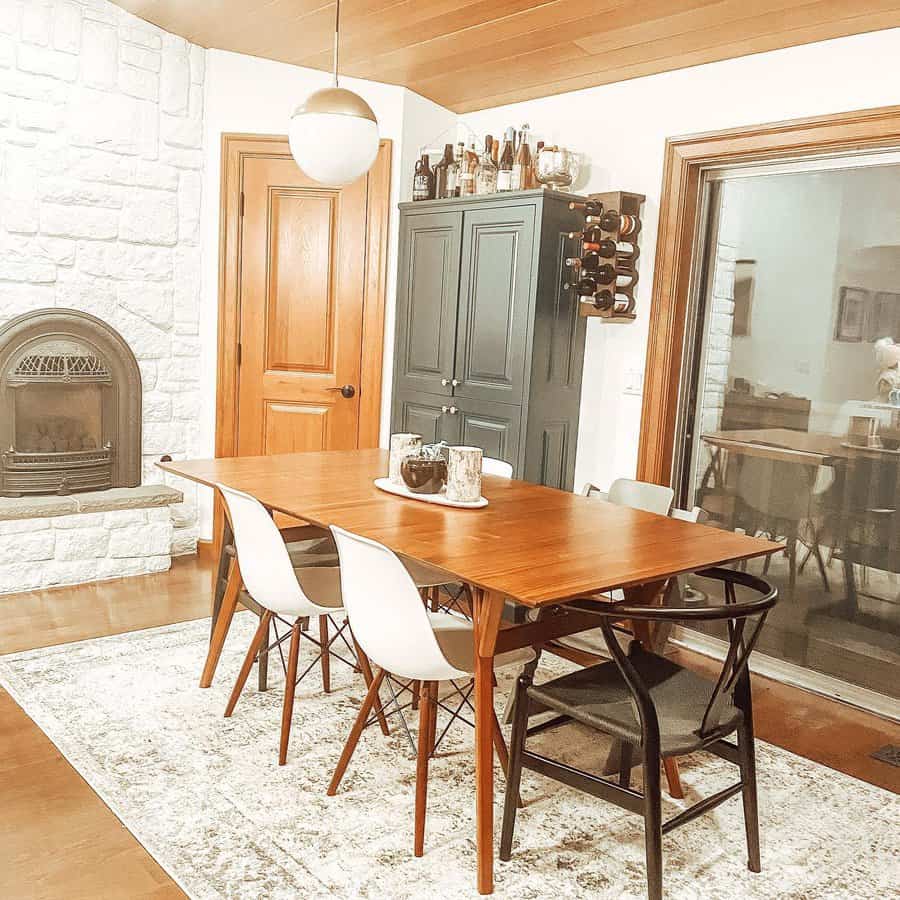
328, 526, 534, 856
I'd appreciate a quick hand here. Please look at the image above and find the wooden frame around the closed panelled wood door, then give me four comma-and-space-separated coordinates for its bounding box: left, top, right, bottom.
215, 133, 392, 457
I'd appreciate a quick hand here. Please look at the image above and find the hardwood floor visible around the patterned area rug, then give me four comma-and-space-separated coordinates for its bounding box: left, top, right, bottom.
0, 557, 900, 900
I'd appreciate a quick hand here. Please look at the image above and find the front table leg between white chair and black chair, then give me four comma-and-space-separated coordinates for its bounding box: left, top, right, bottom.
473, 589, 503, 894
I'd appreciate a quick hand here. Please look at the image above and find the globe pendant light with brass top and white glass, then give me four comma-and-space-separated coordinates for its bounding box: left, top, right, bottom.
288, 0, 378, 187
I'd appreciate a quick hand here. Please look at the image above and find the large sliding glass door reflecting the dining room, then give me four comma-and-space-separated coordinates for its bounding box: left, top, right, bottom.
675, 154, 900, 699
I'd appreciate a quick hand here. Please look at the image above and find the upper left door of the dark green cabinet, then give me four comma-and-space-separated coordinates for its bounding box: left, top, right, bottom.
395, 212, 462, 396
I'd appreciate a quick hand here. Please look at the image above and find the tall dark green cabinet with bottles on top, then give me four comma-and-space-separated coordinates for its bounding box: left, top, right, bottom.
391, 191, 585, 489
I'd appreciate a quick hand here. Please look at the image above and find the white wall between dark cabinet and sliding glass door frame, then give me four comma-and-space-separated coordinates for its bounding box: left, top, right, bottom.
462, 29, 900, 485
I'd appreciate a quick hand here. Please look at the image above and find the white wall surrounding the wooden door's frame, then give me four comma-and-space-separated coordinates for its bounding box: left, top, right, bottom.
200, 50, 456, 536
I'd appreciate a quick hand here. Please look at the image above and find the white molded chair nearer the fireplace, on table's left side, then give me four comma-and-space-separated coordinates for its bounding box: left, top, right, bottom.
216, 484, 386, 766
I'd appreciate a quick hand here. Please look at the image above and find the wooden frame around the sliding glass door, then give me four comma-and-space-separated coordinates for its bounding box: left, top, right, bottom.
637, 106, 900, 484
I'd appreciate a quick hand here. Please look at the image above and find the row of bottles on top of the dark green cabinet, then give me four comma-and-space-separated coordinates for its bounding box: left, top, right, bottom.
412, 125, 579, 200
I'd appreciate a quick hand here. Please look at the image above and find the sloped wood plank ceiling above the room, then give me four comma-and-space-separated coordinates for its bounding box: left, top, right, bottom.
117, 0, 900, 112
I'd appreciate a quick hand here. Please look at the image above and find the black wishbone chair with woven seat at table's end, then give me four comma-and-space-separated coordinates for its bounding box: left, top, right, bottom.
500, 568, 778, 900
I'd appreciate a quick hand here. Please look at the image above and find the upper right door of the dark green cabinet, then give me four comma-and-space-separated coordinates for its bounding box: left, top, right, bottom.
456, 205, 535, 404
